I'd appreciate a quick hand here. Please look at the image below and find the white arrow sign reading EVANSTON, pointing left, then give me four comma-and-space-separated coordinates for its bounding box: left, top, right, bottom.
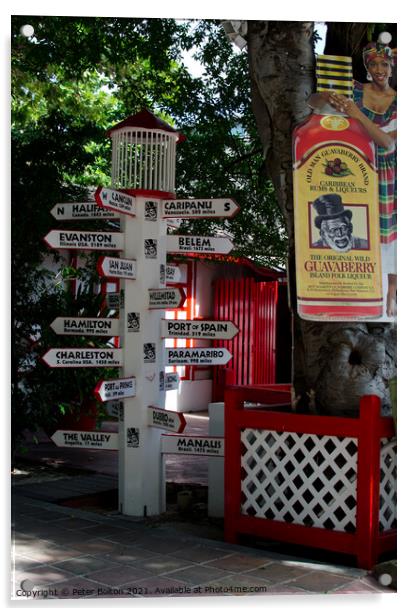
43, 229, 124, 251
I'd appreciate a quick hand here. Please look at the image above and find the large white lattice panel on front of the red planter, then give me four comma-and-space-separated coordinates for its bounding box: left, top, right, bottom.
241, 428, 357, 532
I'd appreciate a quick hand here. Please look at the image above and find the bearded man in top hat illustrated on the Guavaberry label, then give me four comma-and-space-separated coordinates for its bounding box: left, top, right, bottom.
312, 194, 369, 252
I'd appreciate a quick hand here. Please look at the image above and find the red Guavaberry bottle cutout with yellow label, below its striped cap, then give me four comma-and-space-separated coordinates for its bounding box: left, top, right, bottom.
294, 114, 383, 321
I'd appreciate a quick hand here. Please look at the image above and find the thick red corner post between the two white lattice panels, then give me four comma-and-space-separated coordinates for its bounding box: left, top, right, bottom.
356, 396, 381, 569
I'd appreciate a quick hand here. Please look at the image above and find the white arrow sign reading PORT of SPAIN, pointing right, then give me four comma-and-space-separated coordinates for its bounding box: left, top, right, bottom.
161, 319, 239, 340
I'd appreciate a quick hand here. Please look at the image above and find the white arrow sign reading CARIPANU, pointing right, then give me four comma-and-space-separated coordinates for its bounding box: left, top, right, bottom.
162, 199, 240, 218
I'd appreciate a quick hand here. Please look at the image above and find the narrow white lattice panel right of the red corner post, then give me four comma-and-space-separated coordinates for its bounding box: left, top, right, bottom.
379, 439, 397, 531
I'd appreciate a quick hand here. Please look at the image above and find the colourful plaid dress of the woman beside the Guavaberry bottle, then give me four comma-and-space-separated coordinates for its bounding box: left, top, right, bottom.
354, 81, 397, 244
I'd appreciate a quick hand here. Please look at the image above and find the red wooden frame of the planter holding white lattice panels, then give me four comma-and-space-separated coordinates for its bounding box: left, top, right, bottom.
225, 385, 396, 569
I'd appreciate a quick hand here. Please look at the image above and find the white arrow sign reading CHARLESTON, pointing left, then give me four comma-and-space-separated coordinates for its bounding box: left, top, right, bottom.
42, 348, 123, 368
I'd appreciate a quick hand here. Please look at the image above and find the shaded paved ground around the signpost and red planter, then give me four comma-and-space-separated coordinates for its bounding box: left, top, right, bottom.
12, 417, 393, 600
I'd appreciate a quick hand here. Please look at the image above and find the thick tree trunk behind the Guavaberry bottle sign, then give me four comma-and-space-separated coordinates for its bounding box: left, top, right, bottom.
247, 21, 396, 416
